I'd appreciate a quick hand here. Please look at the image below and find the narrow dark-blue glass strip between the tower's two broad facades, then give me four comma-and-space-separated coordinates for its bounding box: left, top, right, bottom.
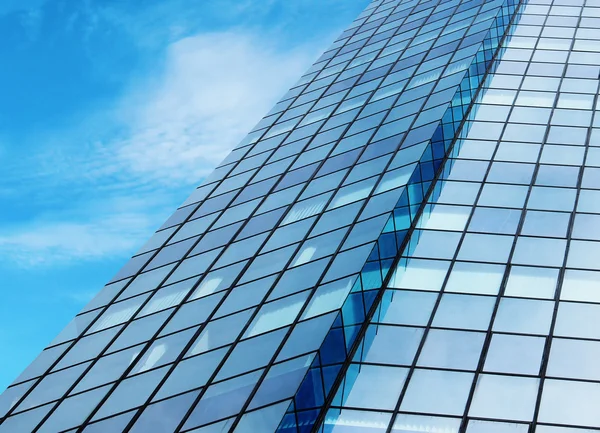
276, 1, 520, 433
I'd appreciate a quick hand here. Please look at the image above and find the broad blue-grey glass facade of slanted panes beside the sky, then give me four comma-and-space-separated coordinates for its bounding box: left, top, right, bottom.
0, 0, 524, 433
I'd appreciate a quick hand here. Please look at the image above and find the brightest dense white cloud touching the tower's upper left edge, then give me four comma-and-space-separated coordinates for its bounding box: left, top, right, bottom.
108, 33, 314, 183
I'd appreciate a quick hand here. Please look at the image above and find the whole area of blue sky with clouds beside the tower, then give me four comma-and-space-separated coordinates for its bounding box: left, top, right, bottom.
0, 0, 368, 391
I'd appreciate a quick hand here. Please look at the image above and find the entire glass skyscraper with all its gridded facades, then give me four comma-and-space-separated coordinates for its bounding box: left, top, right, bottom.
0, 0, 600, 433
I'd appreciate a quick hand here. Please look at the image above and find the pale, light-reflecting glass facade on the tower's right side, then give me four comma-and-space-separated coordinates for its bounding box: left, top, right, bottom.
322, 0, 600, 433
